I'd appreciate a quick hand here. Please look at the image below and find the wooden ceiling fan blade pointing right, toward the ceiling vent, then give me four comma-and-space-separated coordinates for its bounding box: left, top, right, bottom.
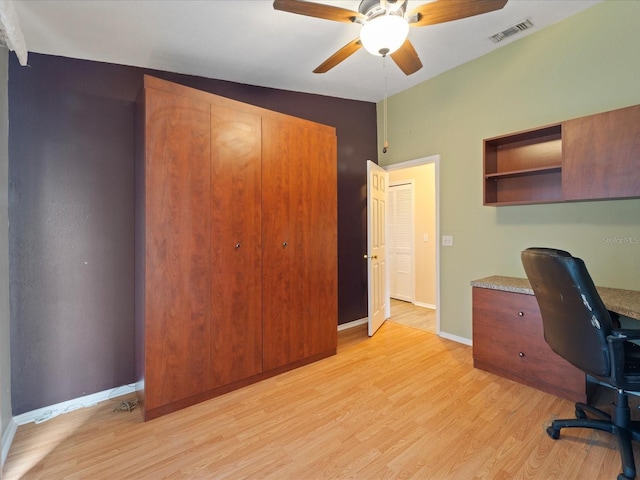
407, 0, 507, 27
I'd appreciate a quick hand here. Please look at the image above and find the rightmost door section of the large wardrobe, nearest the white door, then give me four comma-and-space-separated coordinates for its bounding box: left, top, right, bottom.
262, 117, 337, 371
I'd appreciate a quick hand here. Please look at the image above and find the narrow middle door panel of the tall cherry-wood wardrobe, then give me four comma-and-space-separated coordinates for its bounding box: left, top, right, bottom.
211, 105, 262, 388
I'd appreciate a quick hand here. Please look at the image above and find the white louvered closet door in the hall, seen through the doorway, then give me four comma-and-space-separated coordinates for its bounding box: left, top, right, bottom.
386, 182, 415, 302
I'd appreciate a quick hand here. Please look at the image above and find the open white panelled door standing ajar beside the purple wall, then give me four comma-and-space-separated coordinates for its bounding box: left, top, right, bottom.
365, 160, 390, 336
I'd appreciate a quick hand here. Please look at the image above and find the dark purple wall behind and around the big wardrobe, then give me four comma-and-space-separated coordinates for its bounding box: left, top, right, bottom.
9, 54, 377, 415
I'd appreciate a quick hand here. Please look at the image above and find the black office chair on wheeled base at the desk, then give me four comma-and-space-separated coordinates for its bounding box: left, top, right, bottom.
522, 248, 640, 480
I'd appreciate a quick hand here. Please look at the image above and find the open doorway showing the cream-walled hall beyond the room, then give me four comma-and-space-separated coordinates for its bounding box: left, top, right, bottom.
385, 155, 440, 334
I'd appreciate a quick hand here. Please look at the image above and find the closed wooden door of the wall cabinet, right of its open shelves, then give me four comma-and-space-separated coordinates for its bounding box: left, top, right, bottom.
562, 105, 640, 200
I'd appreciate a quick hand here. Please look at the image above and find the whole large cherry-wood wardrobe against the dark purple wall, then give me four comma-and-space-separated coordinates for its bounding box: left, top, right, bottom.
135, 76, 337, 420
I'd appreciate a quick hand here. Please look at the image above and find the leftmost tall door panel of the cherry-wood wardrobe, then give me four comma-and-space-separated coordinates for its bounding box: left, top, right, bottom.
144, 89, 211, 410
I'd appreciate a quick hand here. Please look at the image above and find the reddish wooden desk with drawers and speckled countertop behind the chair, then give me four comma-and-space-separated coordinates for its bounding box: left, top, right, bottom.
471, 276, 640, 402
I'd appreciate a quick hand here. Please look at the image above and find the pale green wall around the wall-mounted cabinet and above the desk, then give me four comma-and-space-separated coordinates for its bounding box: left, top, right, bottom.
378, 0, 640, 339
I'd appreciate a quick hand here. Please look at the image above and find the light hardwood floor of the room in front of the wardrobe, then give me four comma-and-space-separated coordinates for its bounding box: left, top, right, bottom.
4, 322, 638, 480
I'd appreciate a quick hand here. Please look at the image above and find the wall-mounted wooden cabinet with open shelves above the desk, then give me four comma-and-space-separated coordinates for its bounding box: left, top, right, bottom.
484, 105, 640, 206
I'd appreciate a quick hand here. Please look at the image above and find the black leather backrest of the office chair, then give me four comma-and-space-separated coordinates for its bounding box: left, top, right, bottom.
521, 248, 612, 377
